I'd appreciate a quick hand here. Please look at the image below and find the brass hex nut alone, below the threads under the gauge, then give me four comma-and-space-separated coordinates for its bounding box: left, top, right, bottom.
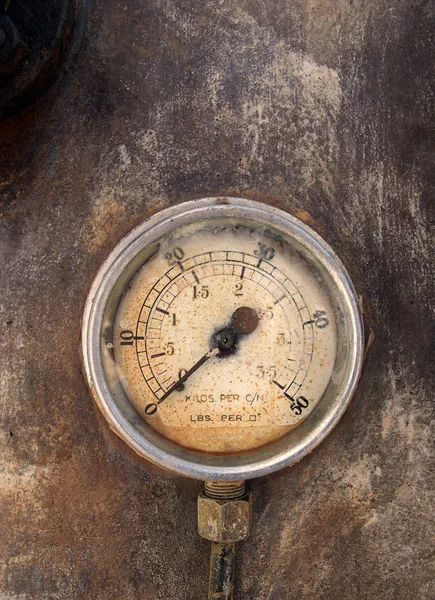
198, 493, 251, 542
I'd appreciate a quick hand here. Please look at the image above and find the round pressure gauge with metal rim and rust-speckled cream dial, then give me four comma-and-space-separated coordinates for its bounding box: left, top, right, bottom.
82, 198, 363, 481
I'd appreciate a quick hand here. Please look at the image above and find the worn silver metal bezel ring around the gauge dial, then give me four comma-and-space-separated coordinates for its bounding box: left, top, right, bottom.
82, 198, 364, 481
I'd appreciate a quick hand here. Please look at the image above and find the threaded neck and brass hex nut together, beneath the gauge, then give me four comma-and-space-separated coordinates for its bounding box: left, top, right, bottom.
198, 481, 251, 543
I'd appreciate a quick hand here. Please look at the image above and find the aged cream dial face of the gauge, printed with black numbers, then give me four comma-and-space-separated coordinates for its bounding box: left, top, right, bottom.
113, 227, 336, 453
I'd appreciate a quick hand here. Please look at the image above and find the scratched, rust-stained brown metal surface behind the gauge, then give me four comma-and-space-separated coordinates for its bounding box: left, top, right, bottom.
0, 0, 435, 600
